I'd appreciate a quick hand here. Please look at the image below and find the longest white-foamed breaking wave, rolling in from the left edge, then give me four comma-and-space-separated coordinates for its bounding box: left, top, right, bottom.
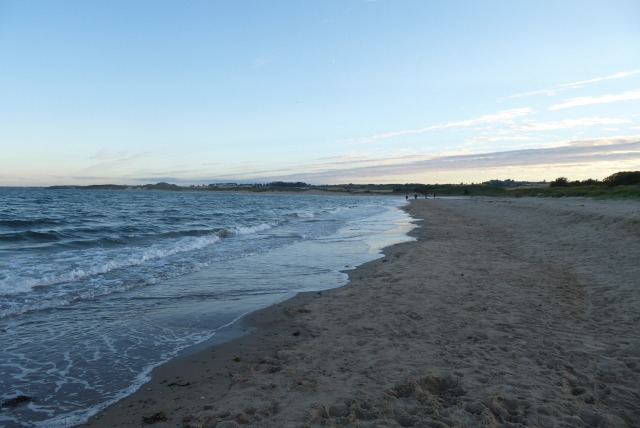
0, 219, 298, 318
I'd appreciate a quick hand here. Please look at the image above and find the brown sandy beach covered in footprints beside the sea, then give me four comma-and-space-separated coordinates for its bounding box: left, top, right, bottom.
82, 198, 640, 428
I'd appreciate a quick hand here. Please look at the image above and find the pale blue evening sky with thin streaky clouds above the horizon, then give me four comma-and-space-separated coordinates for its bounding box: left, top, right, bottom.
0, 0, 640, 186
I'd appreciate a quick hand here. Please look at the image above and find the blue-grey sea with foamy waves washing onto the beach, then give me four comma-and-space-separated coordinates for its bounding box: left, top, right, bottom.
0, 188, 412, 427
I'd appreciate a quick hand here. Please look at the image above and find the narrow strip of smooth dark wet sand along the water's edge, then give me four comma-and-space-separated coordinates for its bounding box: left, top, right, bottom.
79, 206, 421, 428
